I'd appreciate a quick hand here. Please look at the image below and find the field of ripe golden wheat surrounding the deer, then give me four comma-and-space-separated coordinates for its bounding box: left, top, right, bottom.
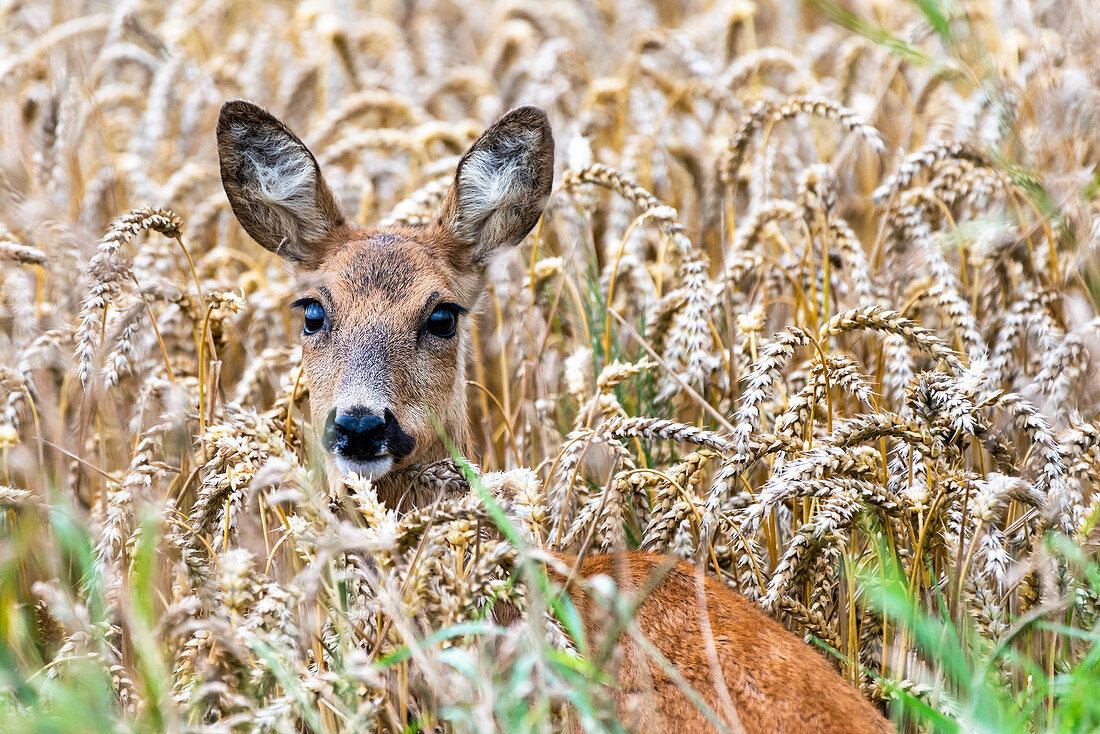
0, 0, 1100, 734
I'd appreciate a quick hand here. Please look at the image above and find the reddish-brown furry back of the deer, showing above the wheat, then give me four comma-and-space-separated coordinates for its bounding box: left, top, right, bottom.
561, 552, 893, 734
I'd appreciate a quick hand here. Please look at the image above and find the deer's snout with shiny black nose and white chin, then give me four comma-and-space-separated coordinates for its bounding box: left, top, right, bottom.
322, 406, 416, 476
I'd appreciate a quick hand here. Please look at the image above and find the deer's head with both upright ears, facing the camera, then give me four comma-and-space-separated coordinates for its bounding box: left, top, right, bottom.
218, 100, 553, 479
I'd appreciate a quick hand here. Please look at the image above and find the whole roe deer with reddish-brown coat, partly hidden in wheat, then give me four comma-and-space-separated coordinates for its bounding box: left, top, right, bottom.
218, 100, 892, 732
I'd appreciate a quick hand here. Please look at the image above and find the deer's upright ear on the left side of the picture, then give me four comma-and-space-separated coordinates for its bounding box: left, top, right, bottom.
218, 99, 344, 266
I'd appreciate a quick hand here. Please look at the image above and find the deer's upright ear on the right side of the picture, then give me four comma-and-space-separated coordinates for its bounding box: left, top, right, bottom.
439, 107, 553, 270
